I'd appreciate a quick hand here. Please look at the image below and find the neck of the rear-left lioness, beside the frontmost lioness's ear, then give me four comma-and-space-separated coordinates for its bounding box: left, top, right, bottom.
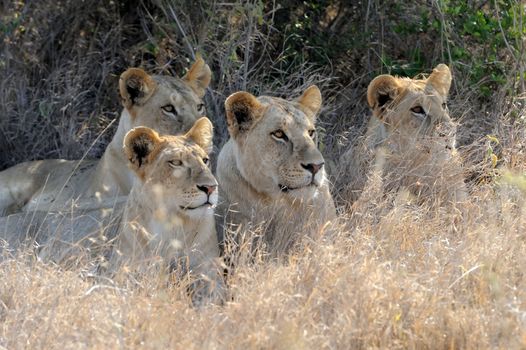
91, 108, 140, 196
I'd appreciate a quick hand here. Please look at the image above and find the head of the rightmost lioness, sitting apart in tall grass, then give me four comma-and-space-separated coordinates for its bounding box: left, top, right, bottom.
367, 64, 457, 151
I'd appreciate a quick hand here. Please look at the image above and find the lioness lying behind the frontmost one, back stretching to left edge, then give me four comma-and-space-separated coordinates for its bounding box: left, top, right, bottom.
0, 58, 211, 215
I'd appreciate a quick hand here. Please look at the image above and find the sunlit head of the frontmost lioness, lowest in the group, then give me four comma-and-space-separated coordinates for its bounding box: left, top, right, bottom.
124, 117, 218, 218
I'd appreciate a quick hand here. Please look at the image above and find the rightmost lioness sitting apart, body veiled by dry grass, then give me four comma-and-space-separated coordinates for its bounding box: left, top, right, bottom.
337, 64, 466, 208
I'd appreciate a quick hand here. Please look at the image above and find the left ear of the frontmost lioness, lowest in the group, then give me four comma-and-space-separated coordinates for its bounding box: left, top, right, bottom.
124, 126, 161, 177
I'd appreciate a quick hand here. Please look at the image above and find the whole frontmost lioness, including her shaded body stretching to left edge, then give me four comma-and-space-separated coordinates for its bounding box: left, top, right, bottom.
0, 117, 224, 300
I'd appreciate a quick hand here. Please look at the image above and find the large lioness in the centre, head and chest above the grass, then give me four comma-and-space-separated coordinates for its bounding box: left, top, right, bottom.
217, 85, 336, 254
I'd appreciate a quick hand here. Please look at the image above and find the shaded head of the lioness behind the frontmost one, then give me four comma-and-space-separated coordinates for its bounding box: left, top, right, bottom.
119, 58, 211, 135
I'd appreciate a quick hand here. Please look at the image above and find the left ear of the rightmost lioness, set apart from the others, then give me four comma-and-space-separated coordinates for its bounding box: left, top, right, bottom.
367, 74, 400, 119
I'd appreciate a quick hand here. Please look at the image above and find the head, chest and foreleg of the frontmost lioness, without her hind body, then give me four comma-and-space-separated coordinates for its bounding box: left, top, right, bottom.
112, 117, 223, 304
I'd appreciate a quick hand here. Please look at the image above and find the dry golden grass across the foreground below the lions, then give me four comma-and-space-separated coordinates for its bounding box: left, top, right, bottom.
0, 179, 526, 349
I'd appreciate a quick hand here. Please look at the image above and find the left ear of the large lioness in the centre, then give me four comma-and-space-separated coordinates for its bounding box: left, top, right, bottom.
225, 91, 263, 137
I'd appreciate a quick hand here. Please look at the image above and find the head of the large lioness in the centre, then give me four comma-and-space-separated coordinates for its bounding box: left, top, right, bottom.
225, 86, 325, 199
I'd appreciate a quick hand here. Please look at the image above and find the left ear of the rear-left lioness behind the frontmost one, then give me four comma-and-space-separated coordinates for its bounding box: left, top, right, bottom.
119, 68, 157, 109
